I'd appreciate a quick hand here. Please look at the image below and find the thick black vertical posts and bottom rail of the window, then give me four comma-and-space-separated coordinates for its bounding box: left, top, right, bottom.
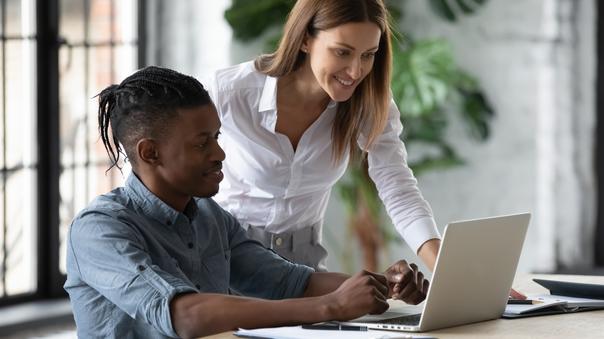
0, 0, 146, 307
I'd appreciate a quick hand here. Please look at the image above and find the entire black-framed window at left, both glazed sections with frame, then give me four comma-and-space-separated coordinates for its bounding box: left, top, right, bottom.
0, 0, 143, 305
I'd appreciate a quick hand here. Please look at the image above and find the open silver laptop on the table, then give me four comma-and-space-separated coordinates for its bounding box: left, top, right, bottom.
341, 213, 531, 332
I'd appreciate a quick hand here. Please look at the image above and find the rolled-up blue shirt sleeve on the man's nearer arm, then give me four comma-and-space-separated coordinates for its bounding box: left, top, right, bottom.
68, 210, 196, 337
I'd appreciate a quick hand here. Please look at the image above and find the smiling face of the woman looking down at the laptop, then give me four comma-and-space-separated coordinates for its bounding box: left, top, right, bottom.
302, 22, 382, 102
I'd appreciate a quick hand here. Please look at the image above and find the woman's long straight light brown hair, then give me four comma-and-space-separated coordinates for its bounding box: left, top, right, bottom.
255, 0, 392, 161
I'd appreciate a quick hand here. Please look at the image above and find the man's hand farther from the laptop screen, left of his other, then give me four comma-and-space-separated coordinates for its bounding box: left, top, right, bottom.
326, 271, 389, 320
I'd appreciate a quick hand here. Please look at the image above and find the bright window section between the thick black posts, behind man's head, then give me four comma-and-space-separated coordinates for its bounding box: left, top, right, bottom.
59, 0, 137, 273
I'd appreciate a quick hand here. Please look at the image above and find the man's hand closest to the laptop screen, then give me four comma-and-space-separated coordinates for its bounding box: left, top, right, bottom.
384, 260, 430, 305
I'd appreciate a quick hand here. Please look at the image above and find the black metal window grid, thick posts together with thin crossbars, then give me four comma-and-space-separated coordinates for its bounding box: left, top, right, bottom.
0, 0, 145, 306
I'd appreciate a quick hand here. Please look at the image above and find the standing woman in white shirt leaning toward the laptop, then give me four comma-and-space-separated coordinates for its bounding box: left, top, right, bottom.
209, 0, 440, 270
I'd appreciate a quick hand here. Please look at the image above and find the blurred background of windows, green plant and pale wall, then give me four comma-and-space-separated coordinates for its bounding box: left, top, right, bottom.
0, 0, 604, 337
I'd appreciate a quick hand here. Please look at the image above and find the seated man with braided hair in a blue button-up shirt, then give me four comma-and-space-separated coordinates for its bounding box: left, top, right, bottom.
65, 67, 428, 339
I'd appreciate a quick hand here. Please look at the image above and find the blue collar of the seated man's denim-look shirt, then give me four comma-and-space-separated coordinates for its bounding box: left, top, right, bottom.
125, 172, 198, 226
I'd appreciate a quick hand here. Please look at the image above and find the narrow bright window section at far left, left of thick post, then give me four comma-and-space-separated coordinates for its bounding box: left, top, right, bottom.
0, 0, 38, 297
